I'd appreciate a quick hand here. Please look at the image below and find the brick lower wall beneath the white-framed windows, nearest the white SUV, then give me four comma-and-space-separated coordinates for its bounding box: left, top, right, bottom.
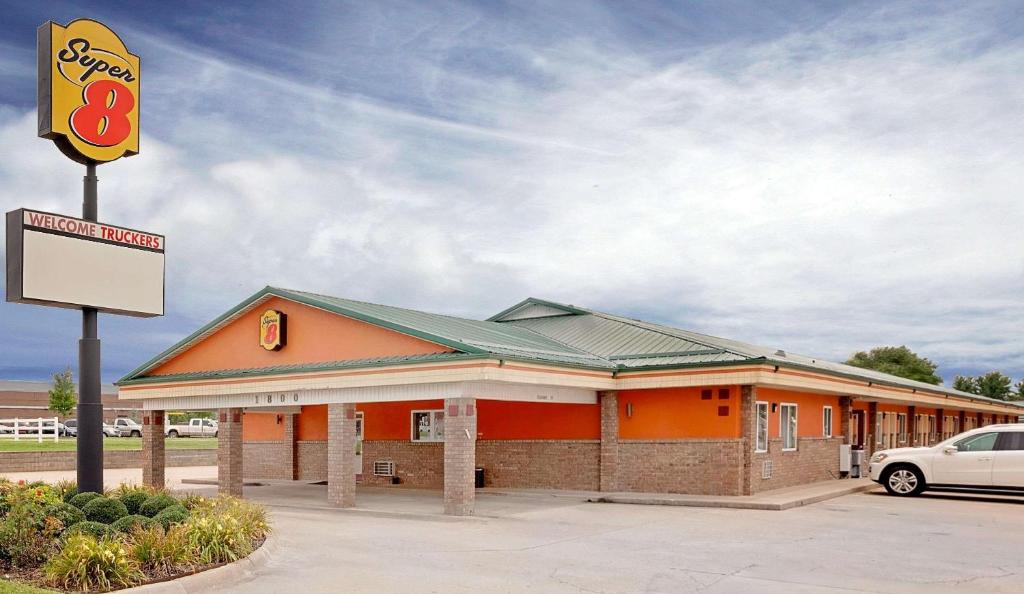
751, 437, 843, 493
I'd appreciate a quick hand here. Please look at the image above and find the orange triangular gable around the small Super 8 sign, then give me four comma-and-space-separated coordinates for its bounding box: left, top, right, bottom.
152, 297, 452, 375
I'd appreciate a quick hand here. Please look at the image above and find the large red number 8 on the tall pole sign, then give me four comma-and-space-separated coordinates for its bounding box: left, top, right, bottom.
71, 80, 135, 146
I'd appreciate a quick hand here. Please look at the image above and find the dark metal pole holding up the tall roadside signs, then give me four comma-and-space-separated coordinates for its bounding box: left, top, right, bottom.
77, 163, 103, 493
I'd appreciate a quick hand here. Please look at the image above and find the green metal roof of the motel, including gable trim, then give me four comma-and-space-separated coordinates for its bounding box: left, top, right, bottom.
118, 287, 1013, 411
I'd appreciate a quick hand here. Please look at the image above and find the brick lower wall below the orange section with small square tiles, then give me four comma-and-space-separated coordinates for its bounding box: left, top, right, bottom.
617, 439, 743, 495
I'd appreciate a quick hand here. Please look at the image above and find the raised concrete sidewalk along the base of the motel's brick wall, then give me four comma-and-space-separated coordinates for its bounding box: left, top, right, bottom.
477, 478, 881, 511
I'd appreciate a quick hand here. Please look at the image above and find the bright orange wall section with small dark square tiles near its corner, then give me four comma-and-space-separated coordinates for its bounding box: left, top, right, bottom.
618, 386, 740, 439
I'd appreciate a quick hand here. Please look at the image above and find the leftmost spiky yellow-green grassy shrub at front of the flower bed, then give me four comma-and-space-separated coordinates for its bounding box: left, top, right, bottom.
45, 535, 144, 592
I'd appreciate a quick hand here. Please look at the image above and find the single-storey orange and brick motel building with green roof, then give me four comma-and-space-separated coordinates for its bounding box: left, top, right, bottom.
119, 287, 1021, 515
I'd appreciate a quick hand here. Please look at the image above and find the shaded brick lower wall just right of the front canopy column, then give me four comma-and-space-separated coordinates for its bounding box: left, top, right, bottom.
476, 439, 601, 491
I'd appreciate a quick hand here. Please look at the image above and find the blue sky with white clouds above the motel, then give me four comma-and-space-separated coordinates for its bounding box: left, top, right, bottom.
0, 0, 1024, 383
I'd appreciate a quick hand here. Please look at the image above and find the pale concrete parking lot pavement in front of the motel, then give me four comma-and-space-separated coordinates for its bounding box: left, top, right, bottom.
214, 494, 1024, 594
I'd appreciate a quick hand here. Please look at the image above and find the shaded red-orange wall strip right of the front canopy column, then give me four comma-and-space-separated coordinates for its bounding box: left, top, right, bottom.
476, 400, 601, 439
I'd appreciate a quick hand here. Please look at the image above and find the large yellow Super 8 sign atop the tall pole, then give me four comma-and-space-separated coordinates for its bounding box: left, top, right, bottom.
38, 18, 139, 163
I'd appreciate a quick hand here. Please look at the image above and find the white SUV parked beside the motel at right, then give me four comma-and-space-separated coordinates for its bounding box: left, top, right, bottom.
868, 423, 1024, 496
